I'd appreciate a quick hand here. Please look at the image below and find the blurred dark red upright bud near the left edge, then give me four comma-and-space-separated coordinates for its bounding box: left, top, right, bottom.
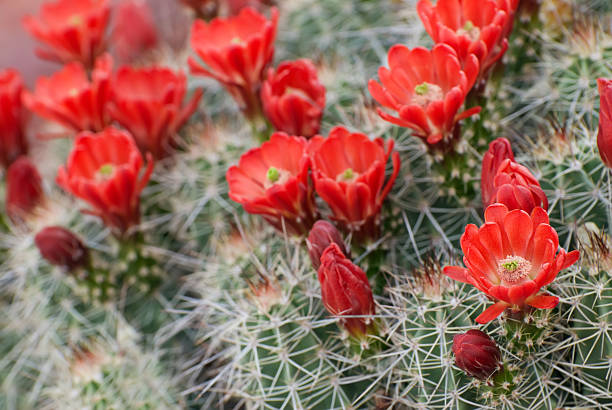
6, 156, 44, 223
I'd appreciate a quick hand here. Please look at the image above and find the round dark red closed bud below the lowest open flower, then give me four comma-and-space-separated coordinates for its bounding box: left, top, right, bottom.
453, 329, 502, 380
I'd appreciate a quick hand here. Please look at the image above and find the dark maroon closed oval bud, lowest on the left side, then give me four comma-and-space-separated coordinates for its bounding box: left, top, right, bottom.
34, 226, 89, 271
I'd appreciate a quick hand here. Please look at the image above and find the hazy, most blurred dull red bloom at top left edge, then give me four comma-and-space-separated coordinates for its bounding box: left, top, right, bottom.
111, 0, 157, 63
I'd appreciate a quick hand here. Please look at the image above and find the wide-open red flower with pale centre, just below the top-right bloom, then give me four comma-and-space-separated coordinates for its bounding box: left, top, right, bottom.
368, 44, 480, 144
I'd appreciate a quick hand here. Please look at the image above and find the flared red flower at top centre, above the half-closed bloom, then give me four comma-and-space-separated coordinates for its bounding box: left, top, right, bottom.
189, 7, 278, 118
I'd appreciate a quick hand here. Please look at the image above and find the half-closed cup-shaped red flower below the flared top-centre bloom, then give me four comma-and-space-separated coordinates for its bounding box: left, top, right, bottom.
261, 59, 325, 138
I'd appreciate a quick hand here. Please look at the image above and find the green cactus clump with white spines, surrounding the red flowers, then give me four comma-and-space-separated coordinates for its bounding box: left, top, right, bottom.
0, 0, 612, 409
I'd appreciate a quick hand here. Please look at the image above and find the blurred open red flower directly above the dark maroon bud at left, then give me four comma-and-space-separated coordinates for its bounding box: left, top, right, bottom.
57, 127, 153, 234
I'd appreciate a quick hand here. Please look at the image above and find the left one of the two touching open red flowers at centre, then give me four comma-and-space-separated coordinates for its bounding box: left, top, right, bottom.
226, 132, 316, 234
